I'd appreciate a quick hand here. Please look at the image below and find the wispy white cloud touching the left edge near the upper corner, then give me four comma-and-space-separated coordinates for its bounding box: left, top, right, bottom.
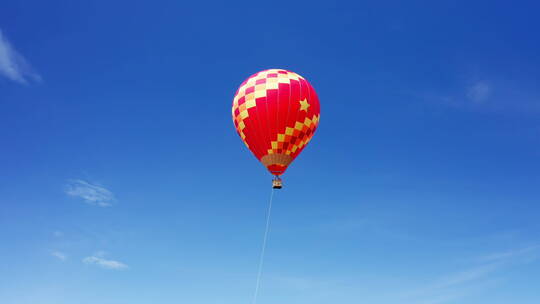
0, 30, 41, 84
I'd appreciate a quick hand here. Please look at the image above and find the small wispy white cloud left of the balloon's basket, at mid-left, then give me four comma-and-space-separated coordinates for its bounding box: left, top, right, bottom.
66, 179, 115, 207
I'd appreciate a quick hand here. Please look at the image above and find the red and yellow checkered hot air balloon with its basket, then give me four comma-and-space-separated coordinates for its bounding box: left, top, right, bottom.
232, 69, 320, 189
